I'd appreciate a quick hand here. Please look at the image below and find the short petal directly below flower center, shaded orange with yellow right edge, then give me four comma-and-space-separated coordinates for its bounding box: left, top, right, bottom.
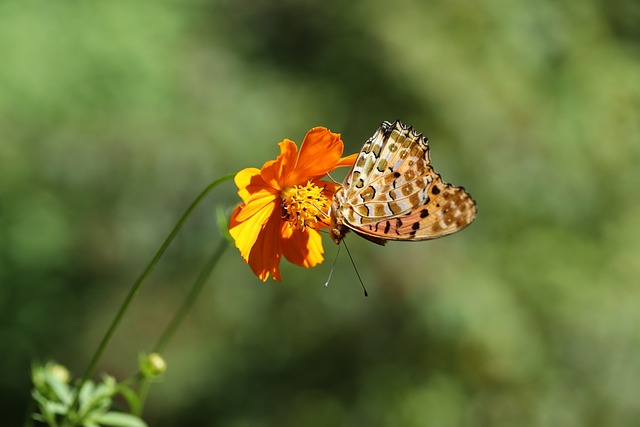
282, 223, 324, 268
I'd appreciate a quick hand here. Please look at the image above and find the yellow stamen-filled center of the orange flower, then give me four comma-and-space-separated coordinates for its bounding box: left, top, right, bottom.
280, 181, 331, 231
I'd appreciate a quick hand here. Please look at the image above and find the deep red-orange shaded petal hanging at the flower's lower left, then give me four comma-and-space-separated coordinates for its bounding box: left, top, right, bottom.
247, 215, 283, 282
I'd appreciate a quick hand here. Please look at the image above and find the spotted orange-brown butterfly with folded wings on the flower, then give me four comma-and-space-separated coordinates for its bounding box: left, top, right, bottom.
329, 120, 477, 245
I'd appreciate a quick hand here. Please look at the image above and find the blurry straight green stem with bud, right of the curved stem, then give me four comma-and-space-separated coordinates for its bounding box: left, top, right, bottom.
133, 240, 229, 417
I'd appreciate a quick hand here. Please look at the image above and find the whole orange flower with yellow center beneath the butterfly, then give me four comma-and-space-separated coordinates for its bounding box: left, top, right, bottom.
229, 127, 357, 281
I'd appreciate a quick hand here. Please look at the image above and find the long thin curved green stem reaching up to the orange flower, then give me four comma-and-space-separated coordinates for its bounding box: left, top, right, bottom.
65, 174, 235, 419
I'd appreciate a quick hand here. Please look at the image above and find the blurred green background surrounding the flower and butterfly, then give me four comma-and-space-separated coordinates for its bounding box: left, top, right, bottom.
0, 0, 640, 427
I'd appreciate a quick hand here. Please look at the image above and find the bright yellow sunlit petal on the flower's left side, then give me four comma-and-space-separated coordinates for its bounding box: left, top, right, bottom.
229, 199, 281, 261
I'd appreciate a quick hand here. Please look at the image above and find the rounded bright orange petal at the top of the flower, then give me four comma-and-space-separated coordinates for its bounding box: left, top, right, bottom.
289, 126, 344, 185
